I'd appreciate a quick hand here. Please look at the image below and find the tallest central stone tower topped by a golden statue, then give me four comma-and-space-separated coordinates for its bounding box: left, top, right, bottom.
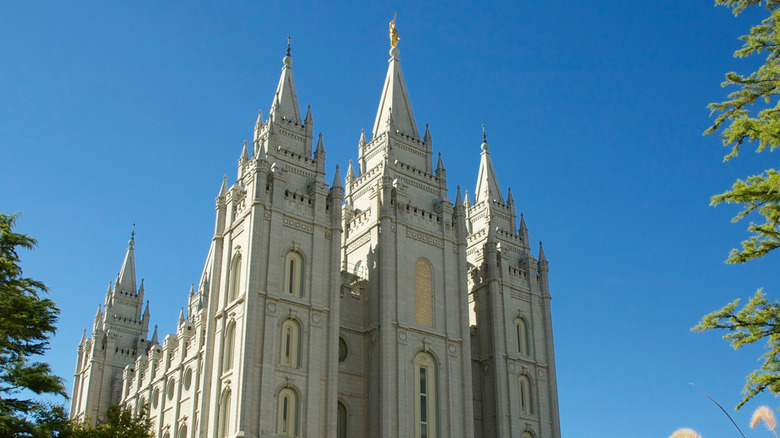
339, 22, 473, 438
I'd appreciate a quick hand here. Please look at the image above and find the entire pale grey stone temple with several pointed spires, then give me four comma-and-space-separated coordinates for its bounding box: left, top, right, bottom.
71, 35, 560, 438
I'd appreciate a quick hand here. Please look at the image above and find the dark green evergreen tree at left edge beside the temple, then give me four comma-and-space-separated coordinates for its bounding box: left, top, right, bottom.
0, 213, 67, 436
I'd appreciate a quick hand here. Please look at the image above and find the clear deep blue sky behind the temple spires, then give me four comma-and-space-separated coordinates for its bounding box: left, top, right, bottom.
0, 0, 780, 438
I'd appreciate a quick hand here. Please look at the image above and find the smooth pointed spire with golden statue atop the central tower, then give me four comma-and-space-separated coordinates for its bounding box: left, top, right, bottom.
372, 21, 420, 139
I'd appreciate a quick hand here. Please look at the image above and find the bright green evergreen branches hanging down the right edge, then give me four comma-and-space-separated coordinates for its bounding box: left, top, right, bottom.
693, 0, 780, 409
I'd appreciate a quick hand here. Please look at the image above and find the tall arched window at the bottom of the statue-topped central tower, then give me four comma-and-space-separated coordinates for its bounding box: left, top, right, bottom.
414, 353, 438, 438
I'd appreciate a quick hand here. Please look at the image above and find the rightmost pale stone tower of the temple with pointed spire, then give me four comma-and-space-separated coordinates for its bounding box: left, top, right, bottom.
466, 132, 560, 438
